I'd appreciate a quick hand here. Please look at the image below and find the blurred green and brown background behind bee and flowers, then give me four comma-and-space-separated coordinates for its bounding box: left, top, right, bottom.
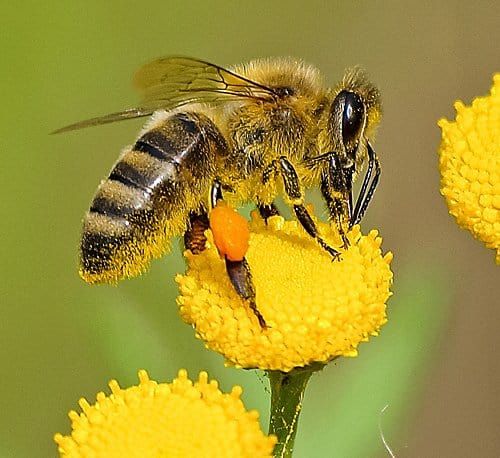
0, 0, 500, 458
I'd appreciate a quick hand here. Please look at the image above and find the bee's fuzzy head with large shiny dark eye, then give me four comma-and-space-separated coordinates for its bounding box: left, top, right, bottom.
326, 68, 381, 161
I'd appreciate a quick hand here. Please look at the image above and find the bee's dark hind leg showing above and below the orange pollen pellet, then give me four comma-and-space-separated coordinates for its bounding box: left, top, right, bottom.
207, 180, 267, 329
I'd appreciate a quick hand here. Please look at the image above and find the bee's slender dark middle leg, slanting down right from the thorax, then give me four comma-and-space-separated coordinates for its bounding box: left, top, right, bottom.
280, 157, 340, 259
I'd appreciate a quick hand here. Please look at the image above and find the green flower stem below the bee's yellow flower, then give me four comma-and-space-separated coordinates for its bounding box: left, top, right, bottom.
267, 364, 323, 458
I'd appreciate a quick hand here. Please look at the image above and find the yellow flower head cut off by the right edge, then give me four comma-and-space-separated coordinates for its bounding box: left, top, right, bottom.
438, 74, 500, 264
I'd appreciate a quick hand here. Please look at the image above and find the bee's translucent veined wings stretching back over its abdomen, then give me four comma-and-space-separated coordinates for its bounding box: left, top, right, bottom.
52, 57, 276, 134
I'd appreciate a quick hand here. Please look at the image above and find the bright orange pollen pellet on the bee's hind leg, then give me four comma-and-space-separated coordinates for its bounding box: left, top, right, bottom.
210, 202, 250, 261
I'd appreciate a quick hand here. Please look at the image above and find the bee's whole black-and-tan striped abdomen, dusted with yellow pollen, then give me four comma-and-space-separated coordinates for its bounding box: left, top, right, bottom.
80, 113, 225, 283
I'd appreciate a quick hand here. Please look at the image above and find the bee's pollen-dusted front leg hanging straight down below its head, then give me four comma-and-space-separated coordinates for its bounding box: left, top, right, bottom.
321, 155, 354, 248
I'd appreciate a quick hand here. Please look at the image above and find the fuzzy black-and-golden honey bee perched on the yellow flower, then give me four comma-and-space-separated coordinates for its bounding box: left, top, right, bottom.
56, 57, 381, 325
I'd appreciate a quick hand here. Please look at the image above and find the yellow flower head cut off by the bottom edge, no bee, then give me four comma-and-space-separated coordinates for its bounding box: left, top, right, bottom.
54, 370, 276, 458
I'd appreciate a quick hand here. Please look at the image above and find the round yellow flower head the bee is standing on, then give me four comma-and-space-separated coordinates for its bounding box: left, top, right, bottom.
176, 214, 392, 372
